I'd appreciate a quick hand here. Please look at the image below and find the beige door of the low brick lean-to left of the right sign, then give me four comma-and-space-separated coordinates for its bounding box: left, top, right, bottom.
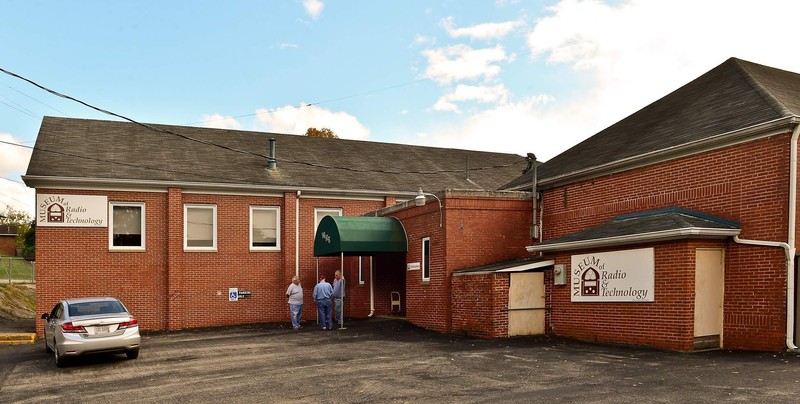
508, 272, 545, 337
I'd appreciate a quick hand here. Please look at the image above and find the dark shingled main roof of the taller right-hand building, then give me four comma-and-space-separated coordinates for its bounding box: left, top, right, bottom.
503, 58, 800, 189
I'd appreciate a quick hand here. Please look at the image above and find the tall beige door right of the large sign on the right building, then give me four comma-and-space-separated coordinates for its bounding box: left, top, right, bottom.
694, 248, 725, 350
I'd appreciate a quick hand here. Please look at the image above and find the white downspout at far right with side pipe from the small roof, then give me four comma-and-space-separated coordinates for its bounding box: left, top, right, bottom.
733, 124, 800, 351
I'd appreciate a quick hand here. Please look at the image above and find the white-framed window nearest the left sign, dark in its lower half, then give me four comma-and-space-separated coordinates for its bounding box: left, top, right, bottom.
108, 202, 145, 251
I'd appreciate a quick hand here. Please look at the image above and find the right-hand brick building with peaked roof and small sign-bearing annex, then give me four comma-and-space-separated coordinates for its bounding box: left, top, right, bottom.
507, 58, 800, 351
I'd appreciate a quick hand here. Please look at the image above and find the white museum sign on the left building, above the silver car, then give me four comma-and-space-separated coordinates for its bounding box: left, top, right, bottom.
36, 194, 108, 227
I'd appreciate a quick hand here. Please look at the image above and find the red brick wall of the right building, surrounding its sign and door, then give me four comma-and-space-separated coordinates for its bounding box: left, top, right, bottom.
542, 134, 789, 350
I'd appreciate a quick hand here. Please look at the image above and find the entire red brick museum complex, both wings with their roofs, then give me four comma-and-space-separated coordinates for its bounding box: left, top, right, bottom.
24, 58, 800, 351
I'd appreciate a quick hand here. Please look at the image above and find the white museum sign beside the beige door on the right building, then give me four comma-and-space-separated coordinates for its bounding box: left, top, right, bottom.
570, 248, 655, 302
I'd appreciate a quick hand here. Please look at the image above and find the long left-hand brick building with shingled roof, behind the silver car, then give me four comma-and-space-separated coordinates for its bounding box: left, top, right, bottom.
23, 117, 527, 332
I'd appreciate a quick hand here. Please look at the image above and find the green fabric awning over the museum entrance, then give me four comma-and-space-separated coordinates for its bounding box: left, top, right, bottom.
314, 216, 408, 257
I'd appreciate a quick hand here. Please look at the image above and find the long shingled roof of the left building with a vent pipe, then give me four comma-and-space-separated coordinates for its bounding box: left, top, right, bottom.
24, 117, 527, 192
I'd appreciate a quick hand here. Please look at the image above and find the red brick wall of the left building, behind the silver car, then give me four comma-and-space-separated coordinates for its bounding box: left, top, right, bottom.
36, 188, 394, 334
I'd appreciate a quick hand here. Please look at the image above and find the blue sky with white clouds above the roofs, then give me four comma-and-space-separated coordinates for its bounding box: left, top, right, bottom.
0, 0, 800, 218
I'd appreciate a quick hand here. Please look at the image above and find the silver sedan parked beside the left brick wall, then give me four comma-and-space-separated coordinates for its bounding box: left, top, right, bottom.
42, 297, 141, 367
